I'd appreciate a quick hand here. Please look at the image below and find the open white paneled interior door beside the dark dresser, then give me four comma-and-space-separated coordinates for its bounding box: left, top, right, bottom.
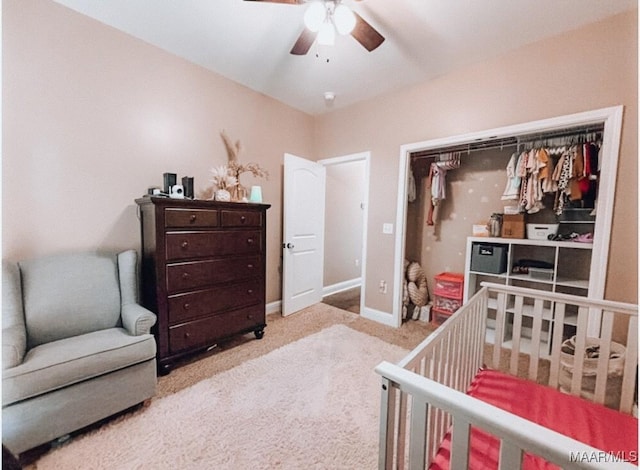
282, 153, 326, 316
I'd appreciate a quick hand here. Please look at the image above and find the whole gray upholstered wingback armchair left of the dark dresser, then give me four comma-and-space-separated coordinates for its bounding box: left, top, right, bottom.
2, 250, 156, 454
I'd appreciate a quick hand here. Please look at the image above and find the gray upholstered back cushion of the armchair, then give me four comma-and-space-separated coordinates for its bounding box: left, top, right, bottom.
19, 253, 121, 349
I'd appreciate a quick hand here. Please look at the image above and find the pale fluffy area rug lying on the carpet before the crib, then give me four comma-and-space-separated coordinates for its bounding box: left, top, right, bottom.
30, 324, 407, 470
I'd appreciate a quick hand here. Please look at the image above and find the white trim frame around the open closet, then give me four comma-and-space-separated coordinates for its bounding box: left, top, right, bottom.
393, 105, 623, 326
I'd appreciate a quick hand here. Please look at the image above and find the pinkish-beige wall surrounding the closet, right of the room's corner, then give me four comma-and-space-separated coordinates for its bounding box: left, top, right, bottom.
316, 10, 638, 312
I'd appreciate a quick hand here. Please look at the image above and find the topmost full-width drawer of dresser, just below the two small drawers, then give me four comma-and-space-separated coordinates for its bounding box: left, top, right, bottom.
166, 230, 262, 261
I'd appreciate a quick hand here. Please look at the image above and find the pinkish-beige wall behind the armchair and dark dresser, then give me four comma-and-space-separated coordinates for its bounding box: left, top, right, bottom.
2, 0, 313, 301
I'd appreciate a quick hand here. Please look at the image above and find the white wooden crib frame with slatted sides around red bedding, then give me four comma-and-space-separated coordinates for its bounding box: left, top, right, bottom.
376, 283, 638, 470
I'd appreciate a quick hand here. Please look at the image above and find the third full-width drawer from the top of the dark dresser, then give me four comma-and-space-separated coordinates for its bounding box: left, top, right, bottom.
167, 278, 264, 325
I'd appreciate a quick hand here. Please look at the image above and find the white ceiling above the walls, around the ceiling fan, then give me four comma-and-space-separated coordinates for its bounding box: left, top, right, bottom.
55, 0, 638, 114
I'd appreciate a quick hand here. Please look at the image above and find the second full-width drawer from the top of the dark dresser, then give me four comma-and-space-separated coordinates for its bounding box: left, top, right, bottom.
167, 255, 264, 294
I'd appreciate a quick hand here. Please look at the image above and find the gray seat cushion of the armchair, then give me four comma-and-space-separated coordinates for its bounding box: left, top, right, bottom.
2, 328, 156, 407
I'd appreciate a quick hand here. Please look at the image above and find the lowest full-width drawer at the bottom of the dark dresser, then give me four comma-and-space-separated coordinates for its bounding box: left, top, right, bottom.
169, 304, 265, 353
